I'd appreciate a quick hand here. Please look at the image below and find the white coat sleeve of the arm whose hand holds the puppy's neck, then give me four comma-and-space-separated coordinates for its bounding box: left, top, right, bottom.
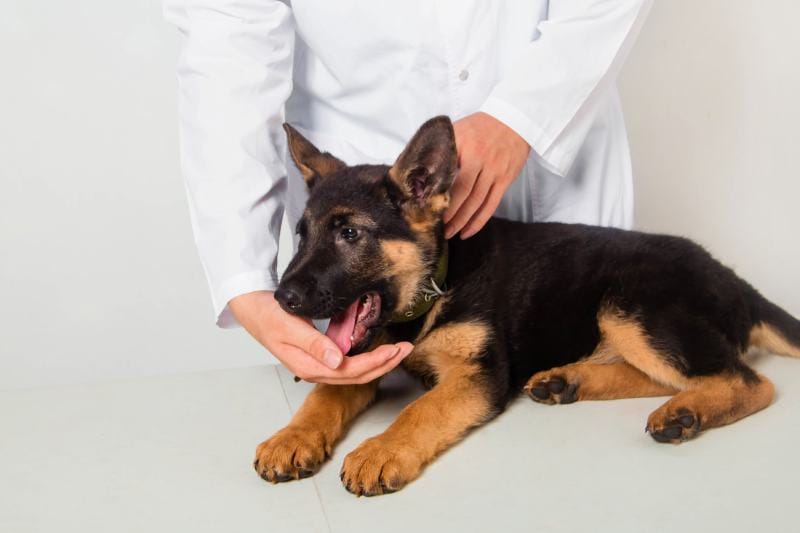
480, 0, 652, 176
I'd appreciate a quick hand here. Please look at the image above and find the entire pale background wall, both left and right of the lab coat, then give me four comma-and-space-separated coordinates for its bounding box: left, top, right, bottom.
0, 0, 800, 388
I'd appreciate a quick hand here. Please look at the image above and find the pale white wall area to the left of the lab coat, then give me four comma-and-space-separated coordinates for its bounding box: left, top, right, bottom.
0, 0, 264, 387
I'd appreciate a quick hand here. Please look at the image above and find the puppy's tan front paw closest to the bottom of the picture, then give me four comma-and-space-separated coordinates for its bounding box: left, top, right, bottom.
339, 437, 423, 496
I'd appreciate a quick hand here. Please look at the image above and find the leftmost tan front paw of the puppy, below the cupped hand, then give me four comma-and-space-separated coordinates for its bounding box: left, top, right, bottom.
253, 426, 331, 483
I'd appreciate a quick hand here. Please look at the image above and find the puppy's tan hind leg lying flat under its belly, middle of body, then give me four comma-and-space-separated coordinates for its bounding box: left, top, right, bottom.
523, 361, 678, 405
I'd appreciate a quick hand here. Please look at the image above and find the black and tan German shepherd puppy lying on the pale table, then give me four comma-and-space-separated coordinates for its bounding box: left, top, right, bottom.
255, 117, 800, 496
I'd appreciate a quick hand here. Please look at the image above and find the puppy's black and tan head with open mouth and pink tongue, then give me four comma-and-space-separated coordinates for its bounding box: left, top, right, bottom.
275, 117, 458, 355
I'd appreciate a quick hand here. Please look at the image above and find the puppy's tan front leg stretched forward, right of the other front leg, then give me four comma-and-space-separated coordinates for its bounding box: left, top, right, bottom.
341, 366, 496, 496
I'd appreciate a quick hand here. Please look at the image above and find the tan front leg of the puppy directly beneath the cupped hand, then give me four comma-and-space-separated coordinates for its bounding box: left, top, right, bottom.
253, 380, 378, 483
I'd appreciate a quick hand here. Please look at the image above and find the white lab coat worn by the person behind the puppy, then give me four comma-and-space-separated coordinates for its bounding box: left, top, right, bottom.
164, 0, 651, 327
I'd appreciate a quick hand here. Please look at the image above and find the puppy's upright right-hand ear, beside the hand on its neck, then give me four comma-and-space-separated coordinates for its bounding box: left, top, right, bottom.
389, 116, 458, 207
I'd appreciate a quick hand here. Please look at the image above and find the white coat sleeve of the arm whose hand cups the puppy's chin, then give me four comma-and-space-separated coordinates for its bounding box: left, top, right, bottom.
163, 0, 294, 327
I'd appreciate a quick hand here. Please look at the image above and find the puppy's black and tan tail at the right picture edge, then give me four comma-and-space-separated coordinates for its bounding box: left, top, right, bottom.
750, 292, 800, 357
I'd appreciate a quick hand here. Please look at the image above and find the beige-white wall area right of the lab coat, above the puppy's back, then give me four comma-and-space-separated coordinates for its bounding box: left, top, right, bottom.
620, 0, 800, 324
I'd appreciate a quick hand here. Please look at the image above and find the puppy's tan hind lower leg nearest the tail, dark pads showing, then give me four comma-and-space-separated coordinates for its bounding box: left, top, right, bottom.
647, 368, 775, 444
